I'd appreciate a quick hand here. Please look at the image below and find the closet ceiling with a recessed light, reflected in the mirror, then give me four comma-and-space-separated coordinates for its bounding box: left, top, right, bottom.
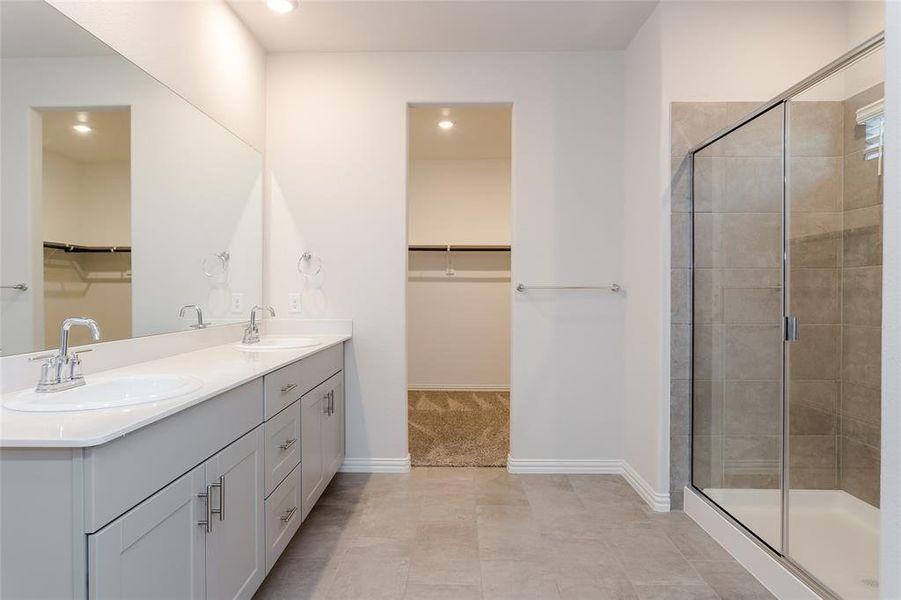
41, 109, 131, 162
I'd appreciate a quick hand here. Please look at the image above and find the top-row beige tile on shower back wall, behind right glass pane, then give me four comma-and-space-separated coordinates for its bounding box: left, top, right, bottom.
788, 101, 844, 156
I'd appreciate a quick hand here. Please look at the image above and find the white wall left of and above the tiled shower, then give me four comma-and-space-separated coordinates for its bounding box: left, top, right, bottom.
624, 1, 879, 502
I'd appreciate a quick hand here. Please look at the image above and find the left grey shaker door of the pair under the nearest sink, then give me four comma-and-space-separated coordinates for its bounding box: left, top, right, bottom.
88, 466, 206, 600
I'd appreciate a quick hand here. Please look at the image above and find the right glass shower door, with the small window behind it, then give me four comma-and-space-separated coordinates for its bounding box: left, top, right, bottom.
783, 50, 883, 600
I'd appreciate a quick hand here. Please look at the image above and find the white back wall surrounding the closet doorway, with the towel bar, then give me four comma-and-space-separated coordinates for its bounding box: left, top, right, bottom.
266, 53, 623, 462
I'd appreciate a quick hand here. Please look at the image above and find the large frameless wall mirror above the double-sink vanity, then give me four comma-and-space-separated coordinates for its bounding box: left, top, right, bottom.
0, 1, 262, 355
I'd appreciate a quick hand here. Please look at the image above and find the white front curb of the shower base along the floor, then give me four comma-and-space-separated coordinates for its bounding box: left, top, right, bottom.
685, 487, 820, 600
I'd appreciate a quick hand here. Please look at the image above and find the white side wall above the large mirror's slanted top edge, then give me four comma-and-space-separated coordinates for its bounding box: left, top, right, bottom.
49, 0, 266, 150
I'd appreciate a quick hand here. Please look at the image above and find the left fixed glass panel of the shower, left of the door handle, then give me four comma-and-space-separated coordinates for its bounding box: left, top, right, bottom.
692, 104, 785, 552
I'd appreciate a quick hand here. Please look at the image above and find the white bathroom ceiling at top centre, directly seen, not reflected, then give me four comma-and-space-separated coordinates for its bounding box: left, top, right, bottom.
228, 0, 657, 52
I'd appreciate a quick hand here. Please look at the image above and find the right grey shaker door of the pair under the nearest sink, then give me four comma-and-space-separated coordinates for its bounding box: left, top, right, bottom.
205, 427, 266, 600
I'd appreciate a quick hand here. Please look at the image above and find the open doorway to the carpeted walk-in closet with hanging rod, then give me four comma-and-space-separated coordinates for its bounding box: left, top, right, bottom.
407, 105, 512, 467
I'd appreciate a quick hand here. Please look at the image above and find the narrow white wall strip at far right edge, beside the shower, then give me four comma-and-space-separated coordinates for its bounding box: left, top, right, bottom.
879, 2, 901, 598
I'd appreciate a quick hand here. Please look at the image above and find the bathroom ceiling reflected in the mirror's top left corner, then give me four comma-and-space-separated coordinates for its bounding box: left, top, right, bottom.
0, 0, 115, 58
